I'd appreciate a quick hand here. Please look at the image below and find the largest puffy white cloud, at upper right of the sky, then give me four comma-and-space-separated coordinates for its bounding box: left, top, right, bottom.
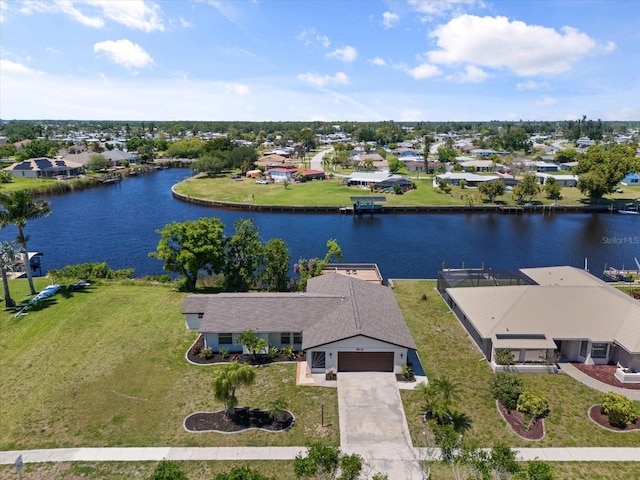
427, 15, 596, 76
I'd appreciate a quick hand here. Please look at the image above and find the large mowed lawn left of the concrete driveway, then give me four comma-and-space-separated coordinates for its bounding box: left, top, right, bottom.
0, 279, 339, 450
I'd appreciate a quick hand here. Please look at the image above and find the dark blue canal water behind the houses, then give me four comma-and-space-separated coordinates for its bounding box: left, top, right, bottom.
0, 169, 640, 278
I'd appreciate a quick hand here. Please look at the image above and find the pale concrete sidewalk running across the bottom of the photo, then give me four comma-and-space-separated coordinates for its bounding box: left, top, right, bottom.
0, 447, 640, 465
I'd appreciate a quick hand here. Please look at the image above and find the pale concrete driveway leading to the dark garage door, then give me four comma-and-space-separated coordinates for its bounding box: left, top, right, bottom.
338, 372, 423, 480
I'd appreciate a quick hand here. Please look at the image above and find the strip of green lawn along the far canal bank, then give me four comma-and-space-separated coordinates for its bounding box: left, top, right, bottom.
175, 176, 640, 208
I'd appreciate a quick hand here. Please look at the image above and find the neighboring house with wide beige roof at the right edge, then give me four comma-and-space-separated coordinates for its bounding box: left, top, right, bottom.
438, 266, 640, 382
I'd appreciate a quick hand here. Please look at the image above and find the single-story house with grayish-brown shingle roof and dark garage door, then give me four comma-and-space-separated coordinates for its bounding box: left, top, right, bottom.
182, 273, 416, 373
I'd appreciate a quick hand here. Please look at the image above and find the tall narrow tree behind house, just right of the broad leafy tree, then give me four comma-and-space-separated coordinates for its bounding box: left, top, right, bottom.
224, 218, 264, 292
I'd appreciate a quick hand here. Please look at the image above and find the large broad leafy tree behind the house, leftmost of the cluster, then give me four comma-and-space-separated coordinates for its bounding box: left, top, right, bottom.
149, 217, 225, 292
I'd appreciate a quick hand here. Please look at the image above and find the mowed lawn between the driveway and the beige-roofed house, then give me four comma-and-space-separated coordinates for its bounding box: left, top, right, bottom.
394, 281, 640, 447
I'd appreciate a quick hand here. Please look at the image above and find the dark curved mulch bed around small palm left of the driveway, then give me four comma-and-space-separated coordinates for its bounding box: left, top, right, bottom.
184, 407, 294, 433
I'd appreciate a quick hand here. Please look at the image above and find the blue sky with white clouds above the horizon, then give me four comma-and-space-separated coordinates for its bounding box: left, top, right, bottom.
0, 0, 640, 121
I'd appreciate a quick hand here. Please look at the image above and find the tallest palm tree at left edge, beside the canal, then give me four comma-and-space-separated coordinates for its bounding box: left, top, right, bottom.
0, 190, 51, 295
